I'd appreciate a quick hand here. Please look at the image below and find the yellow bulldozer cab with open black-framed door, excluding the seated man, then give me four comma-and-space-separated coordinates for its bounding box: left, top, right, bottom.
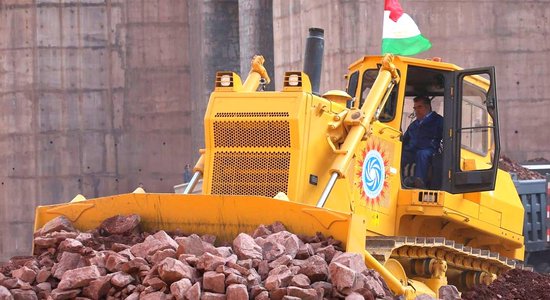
347, 57, 499, 194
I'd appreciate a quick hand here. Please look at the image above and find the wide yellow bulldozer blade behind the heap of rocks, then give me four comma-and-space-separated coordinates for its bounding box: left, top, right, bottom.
34, 193, 366, 253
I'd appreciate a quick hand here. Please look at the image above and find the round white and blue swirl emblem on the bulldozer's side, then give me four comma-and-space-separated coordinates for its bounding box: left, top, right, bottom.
361, 150, 385, 199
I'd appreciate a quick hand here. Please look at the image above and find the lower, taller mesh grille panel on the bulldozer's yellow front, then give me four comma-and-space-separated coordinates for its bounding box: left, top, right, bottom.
211, 151, 290, 197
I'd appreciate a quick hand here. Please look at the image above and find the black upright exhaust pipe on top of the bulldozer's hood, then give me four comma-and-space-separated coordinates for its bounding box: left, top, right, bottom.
304, 28, 325, 94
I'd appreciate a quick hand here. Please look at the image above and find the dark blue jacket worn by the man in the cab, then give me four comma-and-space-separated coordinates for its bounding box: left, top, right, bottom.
403, 111, 443, 153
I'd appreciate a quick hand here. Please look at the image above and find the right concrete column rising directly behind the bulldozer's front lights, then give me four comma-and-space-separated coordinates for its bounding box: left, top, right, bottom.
239, 0, 275, 91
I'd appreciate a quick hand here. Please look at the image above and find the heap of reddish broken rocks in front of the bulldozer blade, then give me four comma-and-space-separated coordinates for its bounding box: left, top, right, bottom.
0, 215, 393, 299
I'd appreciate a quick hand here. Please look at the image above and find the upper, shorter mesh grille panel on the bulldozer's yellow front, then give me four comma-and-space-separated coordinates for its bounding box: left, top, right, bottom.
213, 121, 290, 147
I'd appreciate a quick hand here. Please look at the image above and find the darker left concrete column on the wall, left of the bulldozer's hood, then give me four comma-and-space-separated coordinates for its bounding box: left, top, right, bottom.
188, 0, 240, 159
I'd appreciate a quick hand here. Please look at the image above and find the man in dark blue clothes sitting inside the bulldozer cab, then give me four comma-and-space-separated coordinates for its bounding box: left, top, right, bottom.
401, 96, 443, 188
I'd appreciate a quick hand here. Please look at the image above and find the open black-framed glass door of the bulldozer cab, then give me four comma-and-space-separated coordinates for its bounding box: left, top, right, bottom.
447, 67, 500, 194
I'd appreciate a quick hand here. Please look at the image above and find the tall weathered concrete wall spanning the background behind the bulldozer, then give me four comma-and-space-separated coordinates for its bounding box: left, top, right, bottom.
0, 0, 550, 261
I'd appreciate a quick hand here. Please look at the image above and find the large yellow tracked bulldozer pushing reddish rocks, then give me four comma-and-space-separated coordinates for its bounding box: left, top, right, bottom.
35, 30, 524, 298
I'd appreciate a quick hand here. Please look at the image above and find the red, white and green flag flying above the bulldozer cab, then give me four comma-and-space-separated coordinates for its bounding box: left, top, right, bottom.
382, 0, 432, 55
